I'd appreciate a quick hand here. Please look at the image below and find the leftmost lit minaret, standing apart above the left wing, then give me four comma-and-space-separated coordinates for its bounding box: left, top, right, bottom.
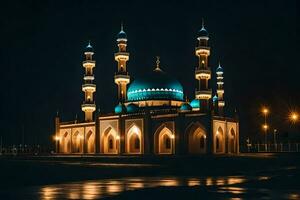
81, 42, 96, 121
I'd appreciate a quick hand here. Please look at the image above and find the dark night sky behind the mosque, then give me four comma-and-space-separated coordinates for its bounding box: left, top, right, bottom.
0, 0, 300, 147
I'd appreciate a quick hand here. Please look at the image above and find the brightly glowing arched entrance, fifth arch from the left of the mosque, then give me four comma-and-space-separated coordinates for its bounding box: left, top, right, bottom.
125, 125, 142, 154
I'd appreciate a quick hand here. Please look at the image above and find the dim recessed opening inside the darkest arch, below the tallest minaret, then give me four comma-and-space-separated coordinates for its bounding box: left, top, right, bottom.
188, 127, 206, 154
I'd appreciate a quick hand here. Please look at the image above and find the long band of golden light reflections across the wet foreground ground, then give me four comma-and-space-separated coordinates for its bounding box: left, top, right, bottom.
39, 176, 246, 200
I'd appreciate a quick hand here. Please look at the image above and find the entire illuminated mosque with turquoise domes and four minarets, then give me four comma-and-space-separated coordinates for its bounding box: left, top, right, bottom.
55, 24, 239, 155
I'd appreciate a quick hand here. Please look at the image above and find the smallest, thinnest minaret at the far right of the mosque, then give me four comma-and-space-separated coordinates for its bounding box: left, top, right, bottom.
216, 63, 225, 115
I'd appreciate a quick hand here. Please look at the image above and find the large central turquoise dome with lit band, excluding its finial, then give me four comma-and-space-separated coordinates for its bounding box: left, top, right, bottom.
127, 69, 183, 101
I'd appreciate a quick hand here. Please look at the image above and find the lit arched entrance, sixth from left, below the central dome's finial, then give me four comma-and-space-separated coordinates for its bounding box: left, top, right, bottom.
154, 127, 175, 154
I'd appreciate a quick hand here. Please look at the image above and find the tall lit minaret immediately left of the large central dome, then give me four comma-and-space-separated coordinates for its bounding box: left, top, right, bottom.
115, 24, 130, 102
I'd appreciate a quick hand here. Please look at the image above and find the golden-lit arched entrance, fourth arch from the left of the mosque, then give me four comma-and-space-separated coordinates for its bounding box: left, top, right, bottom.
101, 127, 119, 154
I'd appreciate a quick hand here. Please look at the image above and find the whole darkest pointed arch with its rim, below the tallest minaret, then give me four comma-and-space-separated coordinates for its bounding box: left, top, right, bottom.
186, 122, 207, 154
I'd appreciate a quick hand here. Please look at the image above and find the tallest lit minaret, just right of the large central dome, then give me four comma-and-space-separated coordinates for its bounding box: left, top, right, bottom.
195, 21, 211, 111
